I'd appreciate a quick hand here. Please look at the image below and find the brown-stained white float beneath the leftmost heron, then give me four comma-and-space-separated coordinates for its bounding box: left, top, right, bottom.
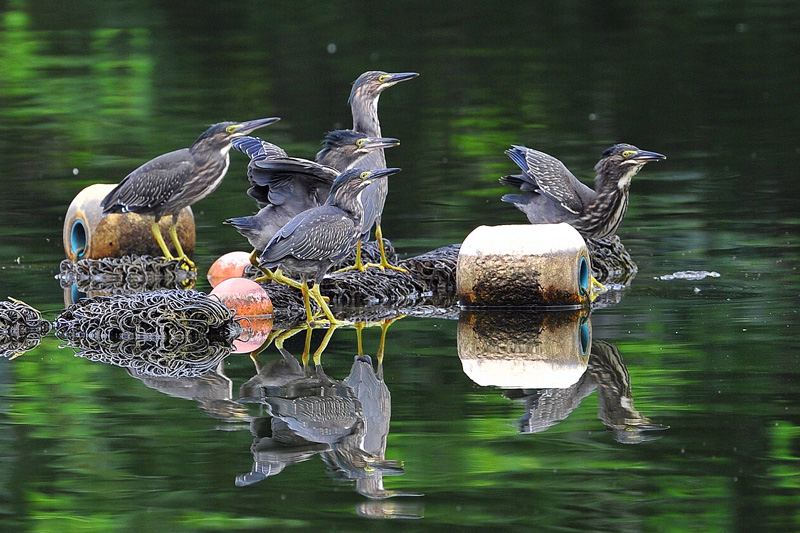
63, 183, 195, 262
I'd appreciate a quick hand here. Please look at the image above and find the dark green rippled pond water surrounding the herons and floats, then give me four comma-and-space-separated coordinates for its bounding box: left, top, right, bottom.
0, 1, 800, 531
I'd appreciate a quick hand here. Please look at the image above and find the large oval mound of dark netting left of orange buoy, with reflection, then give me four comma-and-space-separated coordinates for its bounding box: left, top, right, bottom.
54, 289, 242, 377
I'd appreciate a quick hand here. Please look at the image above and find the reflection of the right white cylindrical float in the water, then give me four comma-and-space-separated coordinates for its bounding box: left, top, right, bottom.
458, 311, 591, 389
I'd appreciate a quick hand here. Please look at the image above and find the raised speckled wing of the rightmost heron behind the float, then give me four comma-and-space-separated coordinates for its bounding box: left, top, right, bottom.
506, 146, 591, 214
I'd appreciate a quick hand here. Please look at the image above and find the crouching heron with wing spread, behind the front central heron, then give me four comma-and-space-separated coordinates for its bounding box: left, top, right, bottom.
225, 130, 400, 250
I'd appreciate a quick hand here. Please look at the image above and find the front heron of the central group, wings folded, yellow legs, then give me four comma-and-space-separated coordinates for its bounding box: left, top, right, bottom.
251, 168, 400, 325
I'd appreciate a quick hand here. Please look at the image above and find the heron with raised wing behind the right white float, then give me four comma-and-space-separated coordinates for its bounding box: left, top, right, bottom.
500, 144, 666, 238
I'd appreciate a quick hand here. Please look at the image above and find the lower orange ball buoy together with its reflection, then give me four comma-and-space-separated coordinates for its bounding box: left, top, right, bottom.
211, 276, 272, 353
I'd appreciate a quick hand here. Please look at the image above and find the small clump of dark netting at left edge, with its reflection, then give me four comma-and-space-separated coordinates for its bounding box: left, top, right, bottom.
0, 298, 52, 359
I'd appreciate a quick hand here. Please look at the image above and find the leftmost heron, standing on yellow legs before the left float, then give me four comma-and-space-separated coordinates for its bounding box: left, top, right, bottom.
101, 117, 280, 268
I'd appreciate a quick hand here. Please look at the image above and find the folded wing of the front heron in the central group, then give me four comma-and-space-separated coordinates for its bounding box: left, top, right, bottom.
260, 206, 357, 265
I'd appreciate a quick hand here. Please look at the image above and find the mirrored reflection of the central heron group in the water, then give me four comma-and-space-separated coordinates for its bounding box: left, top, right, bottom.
236, 320, 419, 504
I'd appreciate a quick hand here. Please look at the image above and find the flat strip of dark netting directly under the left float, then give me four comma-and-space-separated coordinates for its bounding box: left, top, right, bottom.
56, 255, 197, 293
